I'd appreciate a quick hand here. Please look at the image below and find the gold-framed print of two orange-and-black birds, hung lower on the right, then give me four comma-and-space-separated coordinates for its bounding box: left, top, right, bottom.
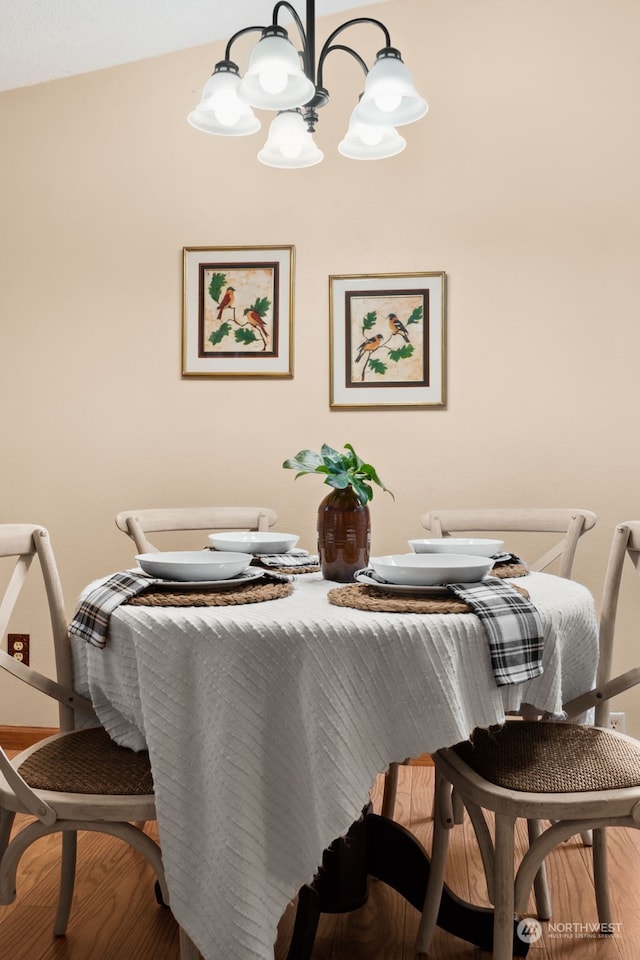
329, 272, 446, 408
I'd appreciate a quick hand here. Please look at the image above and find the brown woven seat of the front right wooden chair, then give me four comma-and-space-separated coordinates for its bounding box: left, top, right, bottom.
452, 720, 640, 793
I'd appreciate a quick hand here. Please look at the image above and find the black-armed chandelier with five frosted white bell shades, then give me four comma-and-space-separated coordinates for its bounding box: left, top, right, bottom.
188, 0, 428, 169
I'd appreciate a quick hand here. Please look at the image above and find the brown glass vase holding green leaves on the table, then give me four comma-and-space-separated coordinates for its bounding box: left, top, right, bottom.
318, 487, 371, 583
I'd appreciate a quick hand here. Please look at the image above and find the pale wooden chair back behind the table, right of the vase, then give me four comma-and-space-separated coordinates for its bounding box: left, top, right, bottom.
420, 507, 596, 577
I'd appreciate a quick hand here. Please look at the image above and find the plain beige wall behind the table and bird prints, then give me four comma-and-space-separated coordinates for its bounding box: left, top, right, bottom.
0, 0, 640, 734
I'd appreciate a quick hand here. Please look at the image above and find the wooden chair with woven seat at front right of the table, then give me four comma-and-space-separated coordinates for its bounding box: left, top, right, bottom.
416, 521, 640, 960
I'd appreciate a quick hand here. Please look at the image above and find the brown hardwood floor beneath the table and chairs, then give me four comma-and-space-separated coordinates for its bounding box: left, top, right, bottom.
0, 766, 640, 960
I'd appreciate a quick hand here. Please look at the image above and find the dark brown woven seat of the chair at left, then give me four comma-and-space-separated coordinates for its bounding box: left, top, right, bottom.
19, 727, 153, 797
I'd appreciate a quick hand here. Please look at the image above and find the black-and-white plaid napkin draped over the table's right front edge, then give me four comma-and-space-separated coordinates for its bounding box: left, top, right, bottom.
447, 576, 544, 687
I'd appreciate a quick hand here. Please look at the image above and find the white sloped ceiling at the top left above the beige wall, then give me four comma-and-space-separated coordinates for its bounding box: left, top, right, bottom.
0, 0, 385, 90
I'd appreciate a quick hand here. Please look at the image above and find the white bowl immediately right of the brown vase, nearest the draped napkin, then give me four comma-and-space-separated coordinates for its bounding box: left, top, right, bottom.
369, 553, 493, 587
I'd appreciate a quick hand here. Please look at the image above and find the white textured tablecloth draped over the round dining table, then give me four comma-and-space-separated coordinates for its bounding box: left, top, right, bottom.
73, 574, 597, 960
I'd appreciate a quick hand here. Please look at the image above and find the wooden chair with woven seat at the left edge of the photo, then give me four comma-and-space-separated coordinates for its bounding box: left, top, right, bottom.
0, 524, 169, 936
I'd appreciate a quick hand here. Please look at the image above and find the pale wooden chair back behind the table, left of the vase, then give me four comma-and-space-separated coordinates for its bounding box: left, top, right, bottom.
116, 507, 278, 553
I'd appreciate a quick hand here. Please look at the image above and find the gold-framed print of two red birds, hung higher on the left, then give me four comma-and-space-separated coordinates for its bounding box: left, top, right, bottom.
182, 247, 294, 377
